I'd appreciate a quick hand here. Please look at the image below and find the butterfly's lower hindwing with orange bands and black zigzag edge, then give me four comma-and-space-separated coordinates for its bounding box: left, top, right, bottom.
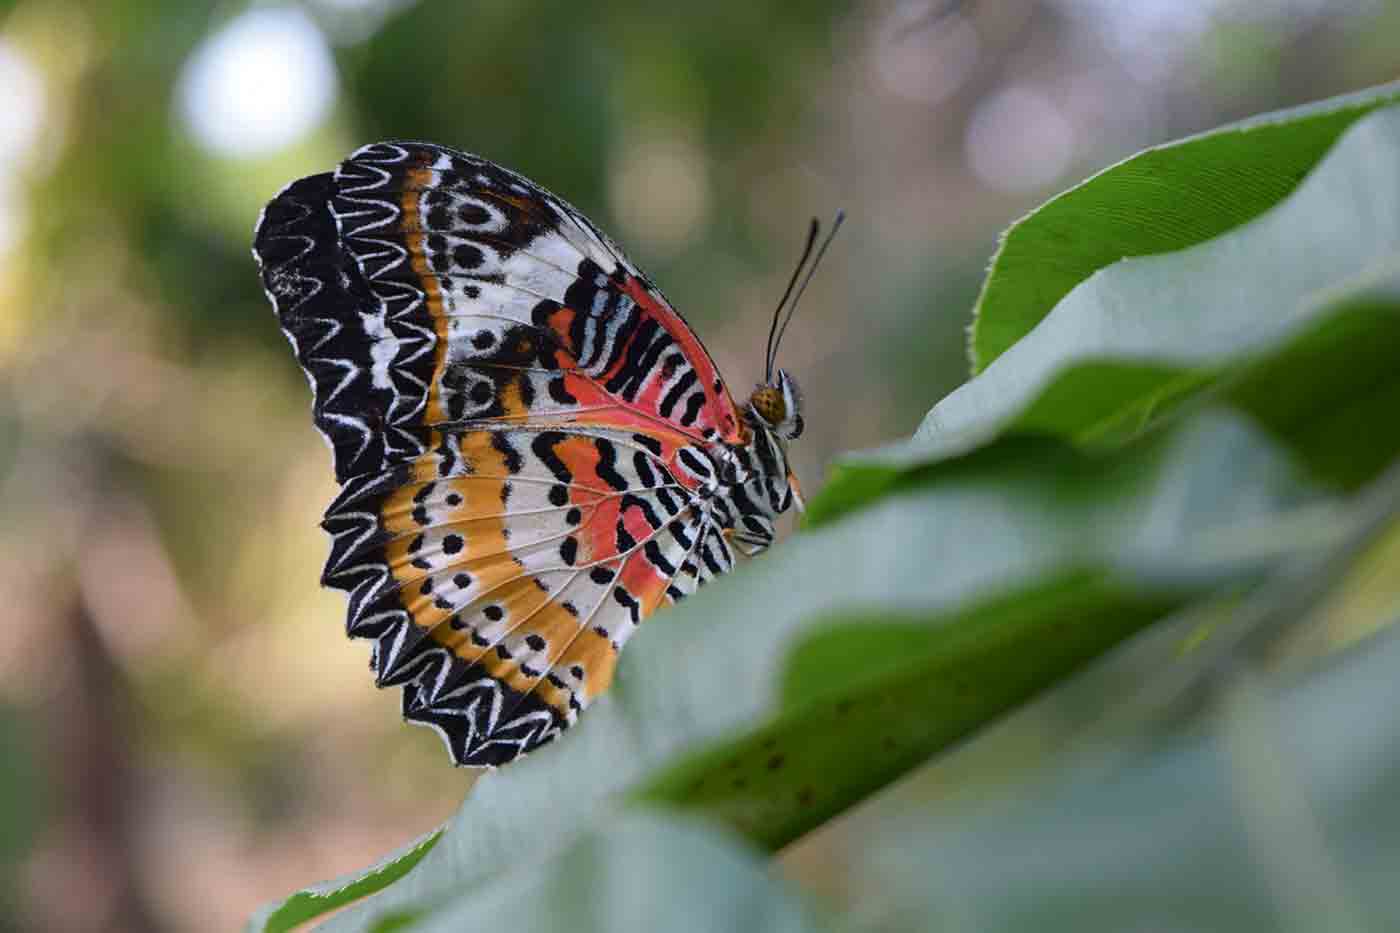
317, 427, 731, 763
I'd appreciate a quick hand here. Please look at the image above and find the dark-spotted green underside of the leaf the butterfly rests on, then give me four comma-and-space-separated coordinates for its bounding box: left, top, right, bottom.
636, 572, 1180, 849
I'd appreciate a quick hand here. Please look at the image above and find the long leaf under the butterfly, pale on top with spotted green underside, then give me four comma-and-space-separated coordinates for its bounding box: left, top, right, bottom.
306, 417, 1310, 930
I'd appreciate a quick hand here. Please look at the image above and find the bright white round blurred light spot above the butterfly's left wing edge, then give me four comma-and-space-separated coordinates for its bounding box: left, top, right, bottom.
178, 8, 336, 156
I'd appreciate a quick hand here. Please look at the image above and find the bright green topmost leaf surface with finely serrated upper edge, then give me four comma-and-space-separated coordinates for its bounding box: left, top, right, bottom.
969, 84, 1400, 373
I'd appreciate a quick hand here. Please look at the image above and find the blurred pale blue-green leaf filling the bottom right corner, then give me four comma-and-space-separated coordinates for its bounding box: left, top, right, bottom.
848, 610, 1400, 933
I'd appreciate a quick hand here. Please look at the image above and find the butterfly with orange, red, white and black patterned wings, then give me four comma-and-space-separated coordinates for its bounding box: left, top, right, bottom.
253, 141, 840, 766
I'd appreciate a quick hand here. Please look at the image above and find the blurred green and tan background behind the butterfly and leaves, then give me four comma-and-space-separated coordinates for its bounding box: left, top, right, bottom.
0, 0, 1400, 932
